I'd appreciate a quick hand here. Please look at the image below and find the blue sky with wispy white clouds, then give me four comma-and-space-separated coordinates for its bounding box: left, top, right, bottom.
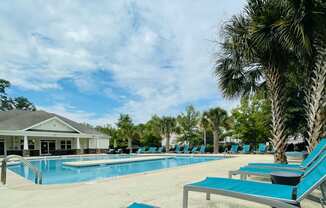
0, 0, 245, 125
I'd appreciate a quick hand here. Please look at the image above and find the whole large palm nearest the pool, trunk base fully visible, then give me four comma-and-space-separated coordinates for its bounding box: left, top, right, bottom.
216, 0, 288, 162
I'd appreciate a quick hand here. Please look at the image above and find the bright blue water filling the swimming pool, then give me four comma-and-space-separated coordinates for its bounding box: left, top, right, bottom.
9, 155, 222, 184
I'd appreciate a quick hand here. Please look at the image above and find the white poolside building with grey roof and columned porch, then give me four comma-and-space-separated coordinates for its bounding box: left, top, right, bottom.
0, 110, 109, 156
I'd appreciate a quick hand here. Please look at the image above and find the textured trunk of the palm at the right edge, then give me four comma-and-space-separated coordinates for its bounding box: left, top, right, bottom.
306, 44, 326, 151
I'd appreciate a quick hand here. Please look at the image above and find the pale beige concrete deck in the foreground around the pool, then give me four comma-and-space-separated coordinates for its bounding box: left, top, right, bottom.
0, 155, 320, 208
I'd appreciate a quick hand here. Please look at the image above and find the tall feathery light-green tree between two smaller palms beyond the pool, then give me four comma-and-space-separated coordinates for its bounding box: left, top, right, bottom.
177, 105, 200, 143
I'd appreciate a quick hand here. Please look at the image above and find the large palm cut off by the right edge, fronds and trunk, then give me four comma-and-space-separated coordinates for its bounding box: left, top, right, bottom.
275, 0, 326, 150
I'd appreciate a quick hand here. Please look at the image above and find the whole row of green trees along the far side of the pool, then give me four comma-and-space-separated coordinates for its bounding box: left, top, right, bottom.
96, 103, 271, 153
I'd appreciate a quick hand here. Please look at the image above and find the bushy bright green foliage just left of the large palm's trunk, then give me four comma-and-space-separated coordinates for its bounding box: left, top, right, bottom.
232, 94, 272, 144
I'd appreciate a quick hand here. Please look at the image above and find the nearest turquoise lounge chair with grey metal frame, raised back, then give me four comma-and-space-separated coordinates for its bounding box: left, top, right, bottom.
183, 157, 326, 208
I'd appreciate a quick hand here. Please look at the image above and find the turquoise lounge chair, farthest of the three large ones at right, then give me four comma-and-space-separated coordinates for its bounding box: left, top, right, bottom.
248, 138, 326, 169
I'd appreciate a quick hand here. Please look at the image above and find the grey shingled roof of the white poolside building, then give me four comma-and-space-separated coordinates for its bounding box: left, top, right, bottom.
0, 110, 102, 135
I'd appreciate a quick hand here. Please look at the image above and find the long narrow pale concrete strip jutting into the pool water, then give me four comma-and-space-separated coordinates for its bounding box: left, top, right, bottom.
63, 156, 173, 167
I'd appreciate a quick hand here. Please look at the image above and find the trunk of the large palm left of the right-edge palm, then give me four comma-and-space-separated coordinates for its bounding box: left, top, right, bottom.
266, 67, 287, 163
